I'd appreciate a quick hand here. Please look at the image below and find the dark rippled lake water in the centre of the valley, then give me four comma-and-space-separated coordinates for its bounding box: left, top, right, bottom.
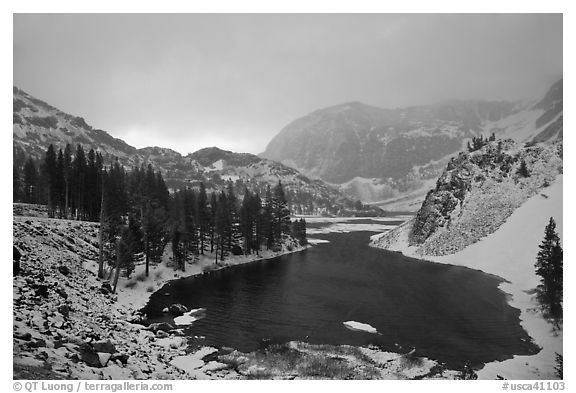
144, 219, 537, 368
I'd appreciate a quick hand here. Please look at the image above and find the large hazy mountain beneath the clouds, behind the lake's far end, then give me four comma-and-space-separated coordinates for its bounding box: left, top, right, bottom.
261, 80, 562, 202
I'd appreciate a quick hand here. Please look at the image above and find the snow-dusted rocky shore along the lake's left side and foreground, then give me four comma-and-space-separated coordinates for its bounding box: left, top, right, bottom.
13, 215, 458, 380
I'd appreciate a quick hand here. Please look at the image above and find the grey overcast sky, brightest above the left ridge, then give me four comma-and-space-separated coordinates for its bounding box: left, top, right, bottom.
14, 14, 562, 154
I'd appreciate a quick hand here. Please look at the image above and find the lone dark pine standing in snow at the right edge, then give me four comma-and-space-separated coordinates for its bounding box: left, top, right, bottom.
535, 217, 563, 303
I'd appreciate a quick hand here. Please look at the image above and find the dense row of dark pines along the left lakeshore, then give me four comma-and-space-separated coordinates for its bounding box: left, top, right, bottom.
13, 145, 306, 283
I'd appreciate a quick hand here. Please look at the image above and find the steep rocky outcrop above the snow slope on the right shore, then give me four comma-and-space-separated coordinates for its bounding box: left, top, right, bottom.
372, 140, 563, 256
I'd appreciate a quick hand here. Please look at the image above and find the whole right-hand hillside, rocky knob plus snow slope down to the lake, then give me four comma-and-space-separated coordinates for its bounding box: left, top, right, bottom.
371, 140, 563, 379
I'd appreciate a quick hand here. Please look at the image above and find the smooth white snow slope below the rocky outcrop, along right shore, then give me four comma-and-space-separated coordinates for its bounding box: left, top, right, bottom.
378, 175, 563, 379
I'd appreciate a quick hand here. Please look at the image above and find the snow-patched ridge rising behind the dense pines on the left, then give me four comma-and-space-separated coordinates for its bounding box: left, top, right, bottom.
13, 87, 382, 216
